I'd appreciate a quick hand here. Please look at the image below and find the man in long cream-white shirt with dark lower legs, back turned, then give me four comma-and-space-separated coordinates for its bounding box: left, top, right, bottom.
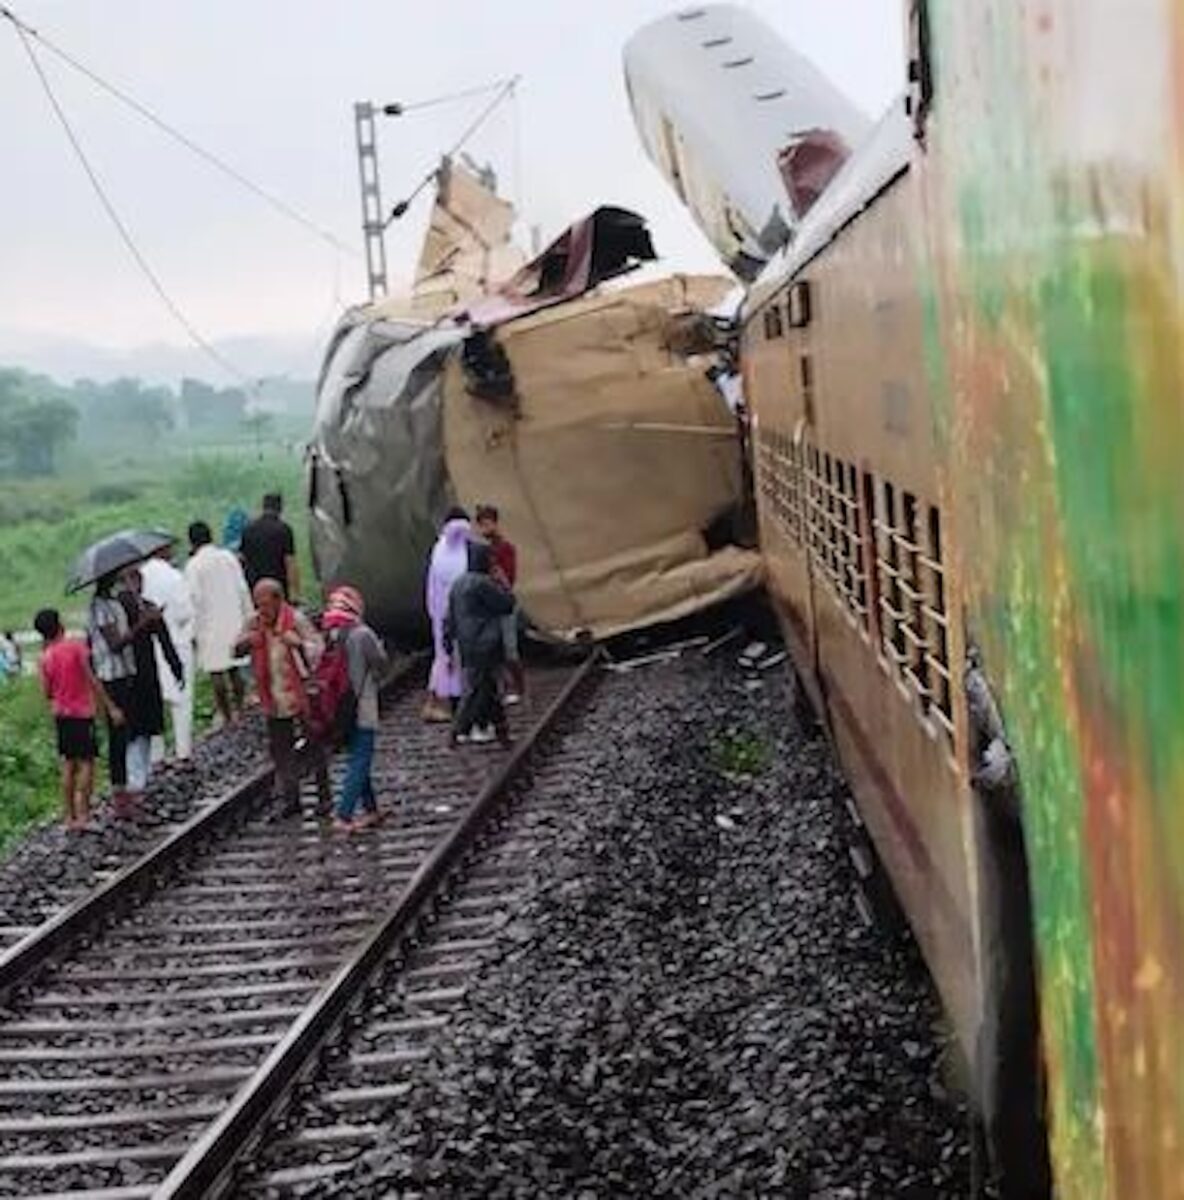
185, 521, 254, 724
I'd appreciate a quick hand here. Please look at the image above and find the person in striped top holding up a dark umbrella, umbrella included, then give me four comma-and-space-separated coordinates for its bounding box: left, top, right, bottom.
66, 529, 173, 816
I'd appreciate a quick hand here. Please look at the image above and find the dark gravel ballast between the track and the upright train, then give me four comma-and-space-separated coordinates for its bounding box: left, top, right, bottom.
343, 659, 969, 1200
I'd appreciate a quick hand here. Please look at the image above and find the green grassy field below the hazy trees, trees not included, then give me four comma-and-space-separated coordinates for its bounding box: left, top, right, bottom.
0, 449, 313, 854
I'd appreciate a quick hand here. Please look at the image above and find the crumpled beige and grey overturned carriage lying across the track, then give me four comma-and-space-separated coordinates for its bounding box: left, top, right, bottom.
309, 227, 761, 640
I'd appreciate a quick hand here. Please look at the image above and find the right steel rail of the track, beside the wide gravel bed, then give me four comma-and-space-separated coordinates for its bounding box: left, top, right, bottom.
154, 652, 600, 1200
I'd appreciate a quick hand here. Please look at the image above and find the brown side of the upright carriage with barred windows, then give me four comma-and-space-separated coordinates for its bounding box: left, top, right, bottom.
743, 124, 980, 1060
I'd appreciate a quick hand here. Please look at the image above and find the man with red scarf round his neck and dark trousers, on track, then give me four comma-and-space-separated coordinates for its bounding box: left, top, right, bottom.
235, 580, 332, 816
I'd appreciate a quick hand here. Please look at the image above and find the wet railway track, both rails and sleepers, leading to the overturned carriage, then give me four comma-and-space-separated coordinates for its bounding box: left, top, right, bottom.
0, 660, 594, 1200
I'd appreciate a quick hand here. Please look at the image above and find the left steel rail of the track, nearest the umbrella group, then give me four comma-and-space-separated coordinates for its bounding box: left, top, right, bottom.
0, 656, 422, 1003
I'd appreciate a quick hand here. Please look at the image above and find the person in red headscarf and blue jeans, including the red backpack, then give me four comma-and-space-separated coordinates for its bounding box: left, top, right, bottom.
313, 586, 390, 833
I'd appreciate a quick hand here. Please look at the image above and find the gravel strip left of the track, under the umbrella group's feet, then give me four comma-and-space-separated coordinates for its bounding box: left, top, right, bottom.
0, 714, 265, 947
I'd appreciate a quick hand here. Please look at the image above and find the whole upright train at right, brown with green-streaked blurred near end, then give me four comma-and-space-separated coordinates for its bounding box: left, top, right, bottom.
623, 0, 1184, 1200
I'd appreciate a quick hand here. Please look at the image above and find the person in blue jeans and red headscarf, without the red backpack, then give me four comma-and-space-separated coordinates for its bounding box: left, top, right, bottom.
323, 586, 390, 833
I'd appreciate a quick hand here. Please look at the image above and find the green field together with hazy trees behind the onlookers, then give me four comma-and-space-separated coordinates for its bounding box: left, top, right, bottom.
0, 367, 313, 853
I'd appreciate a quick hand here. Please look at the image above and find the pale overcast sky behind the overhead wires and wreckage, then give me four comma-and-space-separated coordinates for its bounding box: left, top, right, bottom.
0, 0, 903, 369
